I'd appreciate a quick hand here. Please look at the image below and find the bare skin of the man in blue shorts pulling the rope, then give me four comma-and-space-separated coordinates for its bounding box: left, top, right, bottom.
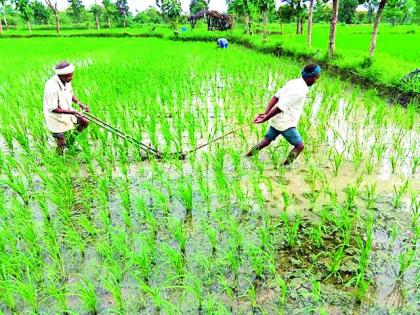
246, 75, 320, 165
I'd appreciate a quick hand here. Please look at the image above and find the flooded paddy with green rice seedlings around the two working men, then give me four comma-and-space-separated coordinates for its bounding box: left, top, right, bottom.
0, 39, 420, 314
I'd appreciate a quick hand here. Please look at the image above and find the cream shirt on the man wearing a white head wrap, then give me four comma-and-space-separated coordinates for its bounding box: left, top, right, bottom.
44, 75, 77, 133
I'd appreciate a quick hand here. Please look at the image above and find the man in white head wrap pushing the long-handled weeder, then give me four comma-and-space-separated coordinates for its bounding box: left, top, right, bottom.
44, 62, 89, 155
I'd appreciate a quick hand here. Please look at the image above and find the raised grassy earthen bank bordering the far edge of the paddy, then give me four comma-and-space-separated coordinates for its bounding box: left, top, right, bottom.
0, 32, 420, 106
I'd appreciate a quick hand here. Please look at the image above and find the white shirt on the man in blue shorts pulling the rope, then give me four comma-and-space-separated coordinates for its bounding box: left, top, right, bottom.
270, 78, 309, 131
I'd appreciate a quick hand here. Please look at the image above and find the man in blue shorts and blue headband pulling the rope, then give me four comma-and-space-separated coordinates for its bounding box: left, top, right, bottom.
247, 64, 321, 165
